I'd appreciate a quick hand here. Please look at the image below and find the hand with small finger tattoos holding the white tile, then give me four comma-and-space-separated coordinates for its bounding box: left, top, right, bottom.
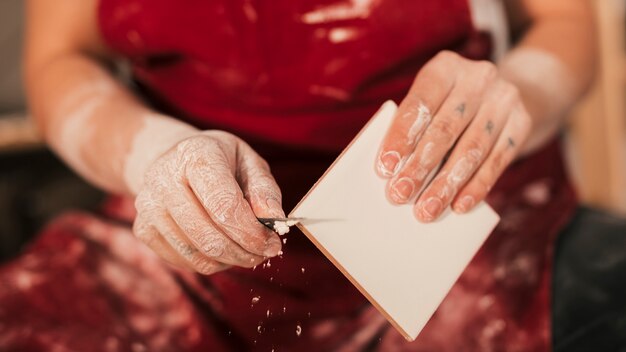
377, 51, 532, 222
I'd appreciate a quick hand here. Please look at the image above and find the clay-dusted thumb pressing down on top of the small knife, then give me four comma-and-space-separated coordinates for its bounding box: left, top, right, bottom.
237, 142, 285, 218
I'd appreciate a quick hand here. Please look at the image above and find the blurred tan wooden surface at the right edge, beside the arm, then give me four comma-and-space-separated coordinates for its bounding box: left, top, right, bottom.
570, 0, 626, 213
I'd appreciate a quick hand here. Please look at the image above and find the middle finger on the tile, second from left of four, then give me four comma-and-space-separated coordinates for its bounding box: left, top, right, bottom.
387, 62, 495, 204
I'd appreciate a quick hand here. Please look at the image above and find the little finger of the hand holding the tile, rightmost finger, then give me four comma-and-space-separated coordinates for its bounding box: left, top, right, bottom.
452, 105, 532, 213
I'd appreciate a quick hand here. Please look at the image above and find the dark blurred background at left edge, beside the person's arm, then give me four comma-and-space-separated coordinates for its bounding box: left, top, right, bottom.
0, 0, 102, 261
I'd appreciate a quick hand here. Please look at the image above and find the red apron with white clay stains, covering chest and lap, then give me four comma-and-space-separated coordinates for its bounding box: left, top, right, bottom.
0, 0, 576, 351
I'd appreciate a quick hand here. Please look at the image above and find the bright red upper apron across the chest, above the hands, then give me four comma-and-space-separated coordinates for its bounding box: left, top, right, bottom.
99, 0, 490, 152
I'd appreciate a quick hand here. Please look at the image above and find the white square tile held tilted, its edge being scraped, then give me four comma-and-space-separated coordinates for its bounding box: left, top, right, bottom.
290, 102, 499, 340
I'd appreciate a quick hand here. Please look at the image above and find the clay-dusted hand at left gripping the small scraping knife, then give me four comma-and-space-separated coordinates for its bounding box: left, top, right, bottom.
133, 131, 285, 274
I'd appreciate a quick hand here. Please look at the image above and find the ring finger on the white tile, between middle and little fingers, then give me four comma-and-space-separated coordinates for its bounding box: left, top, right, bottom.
414, 81, 519, 222
